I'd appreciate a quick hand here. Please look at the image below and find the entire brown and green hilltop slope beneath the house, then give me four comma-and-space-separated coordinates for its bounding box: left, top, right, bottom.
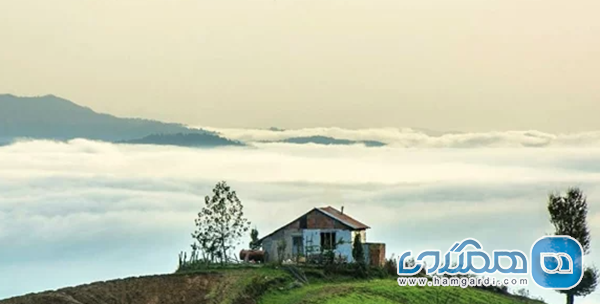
0, 267, 542, 304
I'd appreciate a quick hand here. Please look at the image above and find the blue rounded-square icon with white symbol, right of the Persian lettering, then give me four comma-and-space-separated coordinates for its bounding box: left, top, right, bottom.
531, 236, 583, 290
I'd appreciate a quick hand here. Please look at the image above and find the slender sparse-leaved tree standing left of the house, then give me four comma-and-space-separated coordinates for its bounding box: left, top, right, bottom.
192, 181, 250, 264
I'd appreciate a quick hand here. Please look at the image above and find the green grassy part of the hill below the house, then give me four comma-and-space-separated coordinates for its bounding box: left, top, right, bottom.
177, 267, 543, 304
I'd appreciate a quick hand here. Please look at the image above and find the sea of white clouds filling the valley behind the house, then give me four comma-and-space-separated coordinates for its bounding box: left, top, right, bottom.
0, 129, 600, 304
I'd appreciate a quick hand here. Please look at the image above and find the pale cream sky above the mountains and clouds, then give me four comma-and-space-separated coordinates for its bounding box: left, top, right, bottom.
0, 0, 600, 132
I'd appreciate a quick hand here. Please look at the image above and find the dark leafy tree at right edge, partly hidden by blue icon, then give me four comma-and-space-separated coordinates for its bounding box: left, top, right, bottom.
548, 188, 598, 304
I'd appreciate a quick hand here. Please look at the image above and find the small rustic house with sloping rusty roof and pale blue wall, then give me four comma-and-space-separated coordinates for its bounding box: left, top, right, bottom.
260, 206, 385, 266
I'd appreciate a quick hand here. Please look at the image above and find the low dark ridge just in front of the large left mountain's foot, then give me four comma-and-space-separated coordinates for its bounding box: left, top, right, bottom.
119, 133, 244, 147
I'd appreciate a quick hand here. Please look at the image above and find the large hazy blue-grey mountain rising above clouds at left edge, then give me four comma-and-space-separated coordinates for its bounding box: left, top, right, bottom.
0, 95, 204, 142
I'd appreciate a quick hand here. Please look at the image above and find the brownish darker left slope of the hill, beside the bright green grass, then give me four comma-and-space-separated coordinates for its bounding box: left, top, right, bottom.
0, 268, 289, 304
